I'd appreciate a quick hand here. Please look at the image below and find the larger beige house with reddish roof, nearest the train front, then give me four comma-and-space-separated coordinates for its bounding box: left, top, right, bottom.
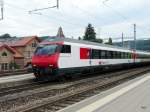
10, 36, 40, 68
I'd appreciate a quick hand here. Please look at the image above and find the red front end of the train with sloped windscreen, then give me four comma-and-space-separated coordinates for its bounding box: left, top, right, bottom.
32, 43, 60, 80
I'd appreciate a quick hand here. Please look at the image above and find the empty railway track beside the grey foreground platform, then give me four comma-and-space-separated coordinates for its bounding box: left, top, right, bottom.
0, 67, 150, 112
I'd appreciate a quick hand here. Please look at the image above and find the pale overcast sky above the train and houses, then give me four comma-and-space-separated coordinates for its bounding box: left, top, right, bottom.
0, 0, 150, 39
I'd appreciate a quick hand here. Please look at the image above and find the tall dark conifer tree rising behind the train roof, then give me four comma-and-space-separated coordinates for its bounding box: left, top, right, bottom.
83, 24, 96, 41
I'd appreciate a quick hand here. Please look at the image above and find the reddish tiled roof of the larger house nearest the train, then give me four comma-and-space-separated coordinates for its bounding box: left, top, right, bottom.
10, 36, 40, 47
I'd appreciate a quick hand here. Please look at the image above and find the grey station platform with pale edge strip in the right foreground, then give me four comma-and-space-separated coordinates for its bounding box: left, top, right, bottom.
58, 73, 150, 112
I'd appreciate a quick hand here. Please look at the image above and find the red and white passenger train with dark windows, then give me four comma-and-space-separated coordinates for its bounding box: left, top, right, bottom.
32, 38, 150, 80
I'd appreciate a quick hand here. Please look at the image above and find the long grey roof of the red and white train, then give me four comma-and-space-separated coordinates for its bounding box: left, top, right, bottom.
44, 37, 150, 54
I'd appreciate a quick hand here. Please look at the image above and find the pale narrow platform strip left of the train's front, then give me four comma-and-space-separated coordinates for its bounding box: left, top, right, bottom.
0, 73, 35, 84
